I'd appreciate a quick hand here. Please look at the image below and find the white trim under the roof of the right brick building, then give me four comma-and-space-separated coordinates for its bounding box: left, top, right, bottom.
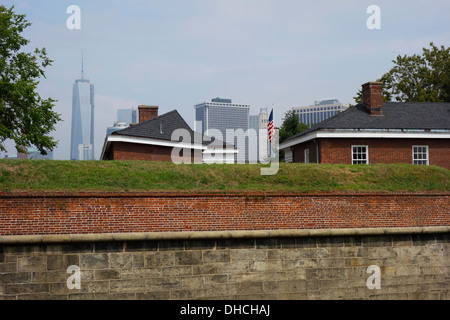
280, 131, 450, 149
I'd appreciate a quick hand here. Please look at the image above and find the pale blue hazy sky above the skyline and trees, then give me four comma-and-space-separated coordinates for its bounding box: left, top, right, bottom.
0, 0, 450, 160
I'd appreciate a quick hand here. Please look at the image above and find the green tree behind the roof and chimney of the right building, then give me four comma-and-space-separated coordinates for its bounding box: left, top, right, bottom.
354, 42, 450, 103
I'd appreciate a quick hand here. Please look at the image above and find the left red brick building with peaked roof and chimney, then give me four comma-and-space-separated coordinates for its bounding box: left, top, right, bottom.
100, 105, 237, 163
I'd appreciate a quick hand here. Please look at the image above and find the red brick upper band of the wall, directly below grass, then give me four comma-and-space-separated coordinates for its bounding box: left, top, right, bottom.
0, 192, 450, 235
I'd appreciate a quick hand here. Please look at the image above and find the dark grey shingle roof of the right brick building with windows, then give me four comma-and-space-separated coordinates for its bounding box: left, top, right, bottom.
283, 102, 450, 143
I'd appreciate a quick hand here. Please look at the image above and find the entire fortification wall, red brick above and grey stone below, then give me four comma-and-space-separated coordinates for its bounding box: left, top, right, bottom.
0, 193, 450, 300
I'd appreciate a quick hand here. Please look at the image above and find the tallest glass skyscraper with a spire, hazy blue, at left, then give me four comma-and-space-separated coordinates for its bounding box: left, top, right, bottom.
70, 58, 94, 160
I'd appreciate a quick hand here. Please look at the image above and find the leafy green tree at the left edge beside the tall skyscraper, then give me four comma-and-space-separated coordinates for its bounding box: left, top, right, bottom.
0, 5, 61, 154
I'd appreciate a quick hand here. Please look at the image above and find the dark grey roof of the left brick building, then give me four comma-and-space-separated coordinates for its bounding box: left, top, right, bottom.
112, 110, 229, 145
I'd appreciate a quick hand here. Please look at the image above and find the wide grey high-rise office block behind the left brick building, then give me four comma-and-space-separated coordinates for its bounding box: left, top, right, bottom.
194, 98, 250, 162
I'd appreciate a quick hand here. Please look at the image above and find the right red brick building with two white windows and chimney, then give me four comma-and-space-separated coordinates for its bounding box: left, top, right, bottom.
280, 82, 450, 170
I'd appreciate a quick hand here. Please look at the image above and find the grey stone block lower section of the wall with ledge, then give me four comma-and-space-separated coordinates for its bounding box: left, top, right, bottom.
0, 228, 450, 300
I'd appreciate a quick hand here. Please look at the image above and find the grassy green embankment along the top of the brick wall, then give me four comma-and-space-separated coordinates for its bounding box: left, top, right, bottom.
0, 160, 450, 192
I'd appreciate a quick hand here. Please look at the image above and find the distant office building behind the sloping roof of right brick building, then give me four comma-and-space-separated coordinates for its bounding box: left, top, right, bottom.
292, 99, 348, 125
